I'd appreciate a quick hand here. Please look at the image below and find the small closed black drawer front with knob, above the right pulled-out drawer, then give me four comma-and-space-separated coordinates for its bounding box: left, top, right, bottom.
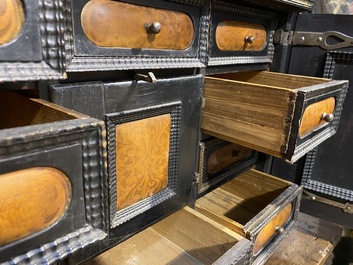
208, 1, 276, 69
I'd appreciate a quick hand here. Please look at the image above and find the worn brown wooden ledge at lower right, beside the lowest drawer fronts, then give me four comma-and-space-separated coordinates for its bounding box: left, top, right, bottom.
265, 213, 342, 265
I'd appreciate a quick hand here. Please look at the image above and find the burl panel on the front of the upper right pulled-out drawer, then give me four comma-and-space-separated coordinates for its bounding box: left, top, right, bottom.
299, 97, 336, 137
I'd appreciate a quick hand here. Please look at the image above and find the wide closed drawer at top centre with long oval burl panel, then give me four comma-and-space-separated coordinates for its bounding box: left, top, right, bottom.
68, 0, 205, 72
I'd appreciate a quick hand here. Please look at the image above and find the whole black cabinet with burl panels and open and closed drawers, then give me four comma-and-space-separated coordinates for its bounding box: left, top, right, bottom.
0, 0, 347, 264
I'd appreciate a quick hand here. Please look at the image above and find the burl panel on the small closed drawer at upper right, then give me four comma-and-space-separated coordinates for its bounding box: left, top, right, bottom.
216, 21, 267, 51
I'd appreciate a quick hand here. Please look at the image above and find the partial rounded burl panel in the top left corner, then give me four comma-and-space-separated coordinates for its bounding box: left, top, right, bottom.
0, 0, 24, 45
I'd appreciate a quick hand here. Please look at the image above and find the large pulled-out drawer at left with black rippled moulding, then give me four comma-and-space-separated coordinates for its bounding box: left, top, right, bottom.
0, 91, 107, 264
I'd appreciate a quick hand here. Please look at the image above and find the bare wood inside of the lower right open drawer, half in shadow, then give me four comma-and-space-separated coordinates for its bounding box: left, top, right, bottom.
196, 169, 291, 233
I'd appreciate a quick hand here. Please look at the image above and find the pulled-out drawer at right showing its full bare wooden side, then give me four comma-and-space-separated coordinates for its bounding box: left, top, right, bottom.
201, 71, 348, 162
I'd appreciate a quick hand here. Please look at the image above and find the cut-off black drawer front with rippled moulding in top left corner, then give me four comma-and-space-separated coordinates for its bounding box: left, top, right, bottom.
0, 0, 67, 82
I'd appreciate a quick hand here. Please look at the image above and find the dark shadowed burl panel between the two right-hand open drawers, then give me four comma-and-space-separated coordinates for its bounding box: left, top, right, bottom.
207, 143, 251, 174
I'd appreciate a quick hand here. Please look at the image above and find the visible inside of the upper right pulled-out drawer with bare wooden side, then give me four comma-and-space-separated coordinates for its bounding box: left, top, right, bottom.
211, 71, 331, 89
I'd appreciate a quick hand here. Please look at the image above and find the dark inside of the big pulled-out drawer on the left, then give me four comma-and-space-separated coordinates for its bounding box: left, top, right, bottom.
0, 91, 88, 129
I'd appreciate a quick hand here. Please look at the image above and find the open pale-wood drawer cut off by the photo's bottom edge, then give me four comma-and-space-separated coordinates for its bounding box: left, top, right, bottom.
84, 207, 251, 265
